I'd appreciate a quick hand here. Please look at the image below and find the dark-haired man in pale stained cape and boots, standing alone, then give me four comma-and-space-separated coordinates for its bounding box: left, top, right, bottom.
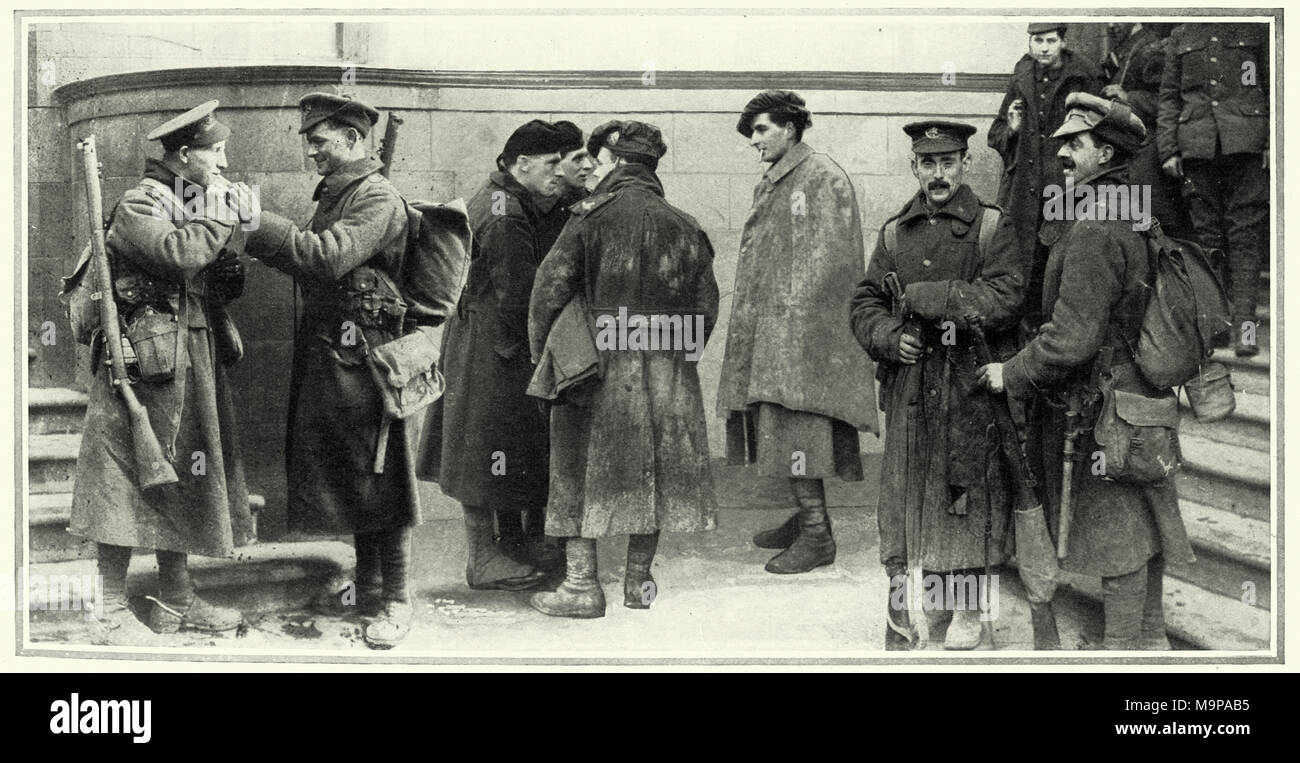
718, 90, 879, 575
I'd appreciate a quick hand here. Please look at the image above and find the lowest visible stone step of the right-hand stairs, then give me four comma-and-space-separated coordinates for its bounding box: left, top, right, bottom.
1057, 571, 1273, 651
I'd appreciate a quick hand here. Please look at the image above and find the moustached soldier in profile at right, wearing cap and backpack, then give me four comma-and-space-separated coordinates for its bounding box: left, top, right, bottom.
979, 92, 1193, 650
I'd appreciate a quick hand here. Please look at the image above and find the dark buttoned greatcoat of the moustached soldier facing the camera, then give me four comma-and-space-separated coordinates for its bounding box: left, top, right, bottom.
850, 185, 1024, 572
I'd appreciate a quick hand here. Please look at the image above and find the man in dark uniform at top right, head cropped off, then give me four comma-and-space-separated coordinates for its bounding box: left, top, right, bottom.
1156, 23, 1270, 356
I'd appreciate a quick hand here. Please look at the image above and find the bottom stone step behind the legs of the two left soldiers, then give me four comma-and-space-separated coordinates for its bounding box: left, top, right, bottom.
29, 541, 356, 620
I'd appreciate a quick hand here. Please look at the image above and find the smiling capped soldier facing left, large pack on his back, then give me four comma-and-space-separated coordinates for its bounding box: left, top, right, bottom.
248, 92, 420, 649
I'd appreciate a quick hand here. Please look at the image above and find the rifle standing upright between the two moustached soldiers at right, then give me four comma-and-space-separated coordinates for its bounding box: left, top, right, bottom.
966, 316, 1061, 649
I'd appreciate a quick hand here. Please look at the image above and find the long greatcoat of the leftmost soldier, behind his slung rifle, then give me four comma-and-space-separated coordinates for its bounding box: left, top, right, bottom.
69, 160, 254, 556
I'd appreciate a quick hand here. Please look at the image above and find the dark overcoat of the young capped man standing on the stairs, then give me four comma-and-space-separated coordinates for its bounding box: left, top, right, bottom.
988, 49, 1101, 324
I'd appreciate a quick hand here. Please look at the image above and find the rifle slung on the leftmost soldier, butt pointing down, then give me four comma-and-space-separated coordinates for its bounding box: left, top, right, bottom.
78, 135, 179, 490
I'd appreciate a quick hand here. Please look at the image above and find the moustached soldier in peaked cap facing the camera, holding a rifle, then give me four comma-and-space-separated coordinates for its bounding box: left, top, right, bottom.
852, 120, 1024, 649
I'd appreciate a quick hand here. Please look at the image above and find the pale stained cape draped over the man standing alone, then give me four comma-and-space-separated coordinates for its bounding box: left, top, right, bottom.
718, 143, 880, 442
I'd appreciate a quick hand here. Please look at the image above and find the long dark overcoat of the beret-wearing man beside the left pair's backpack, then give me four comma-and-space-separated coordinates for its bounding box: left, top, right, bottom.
420, 172, 550, 511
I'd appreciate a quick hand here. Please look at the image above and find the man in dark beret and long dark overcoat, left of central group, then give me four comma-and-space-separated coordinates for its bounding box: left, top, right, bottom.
421, 120, 580, 590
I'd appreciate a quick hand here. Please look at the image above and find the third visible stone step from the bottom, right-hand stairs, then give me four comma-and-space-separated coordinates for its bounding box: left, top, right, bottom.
1177, 434, 1271, 521
